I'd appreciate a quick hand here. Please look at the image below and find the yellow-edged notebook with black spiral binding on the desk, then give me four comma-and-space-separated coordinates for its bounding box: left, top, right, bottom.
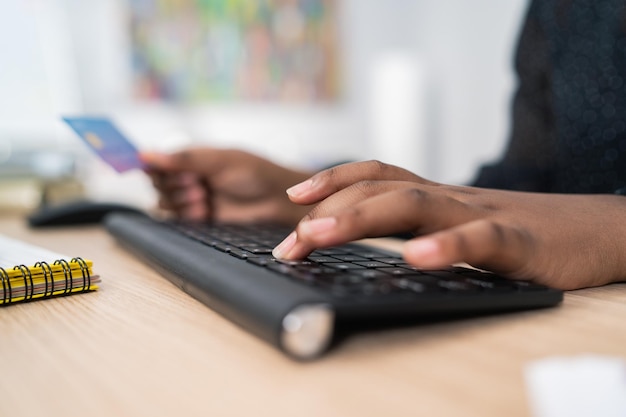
0, 235, 100, 306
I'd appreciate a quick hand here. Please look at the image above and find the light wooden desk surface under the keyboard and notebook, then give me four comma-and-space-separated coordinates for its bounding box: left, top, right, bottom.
0, 217, 626, 417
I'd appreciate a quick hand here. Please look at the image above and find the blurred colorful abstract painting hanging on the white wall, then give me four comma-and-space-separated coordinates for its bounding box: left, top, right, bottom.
129, 0, 340, 103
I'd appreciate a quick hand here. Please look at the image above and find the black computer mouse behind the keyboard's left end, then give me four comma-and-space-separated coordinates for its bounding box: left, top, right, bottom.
28, 200, 145, 227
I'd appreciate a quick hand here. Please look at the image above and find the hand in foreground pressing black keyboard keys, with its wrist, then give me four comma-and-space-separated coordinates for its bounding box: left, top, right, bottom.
274, 161, 626, 289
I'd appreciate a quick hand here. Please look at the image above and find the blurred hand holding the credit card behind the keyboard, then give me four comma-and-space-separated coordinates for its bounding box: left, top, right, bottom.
141, 148, 311, 225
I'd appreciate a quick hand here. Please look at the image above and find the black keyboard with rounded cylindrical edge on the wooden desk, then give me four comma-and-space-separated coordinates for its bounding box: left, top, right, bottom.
105, 213, 563, 359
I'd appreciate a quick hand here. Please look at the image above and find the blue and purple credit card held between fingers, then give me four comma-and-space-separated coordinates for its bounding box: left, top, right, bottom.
63, 117, 143, 172
